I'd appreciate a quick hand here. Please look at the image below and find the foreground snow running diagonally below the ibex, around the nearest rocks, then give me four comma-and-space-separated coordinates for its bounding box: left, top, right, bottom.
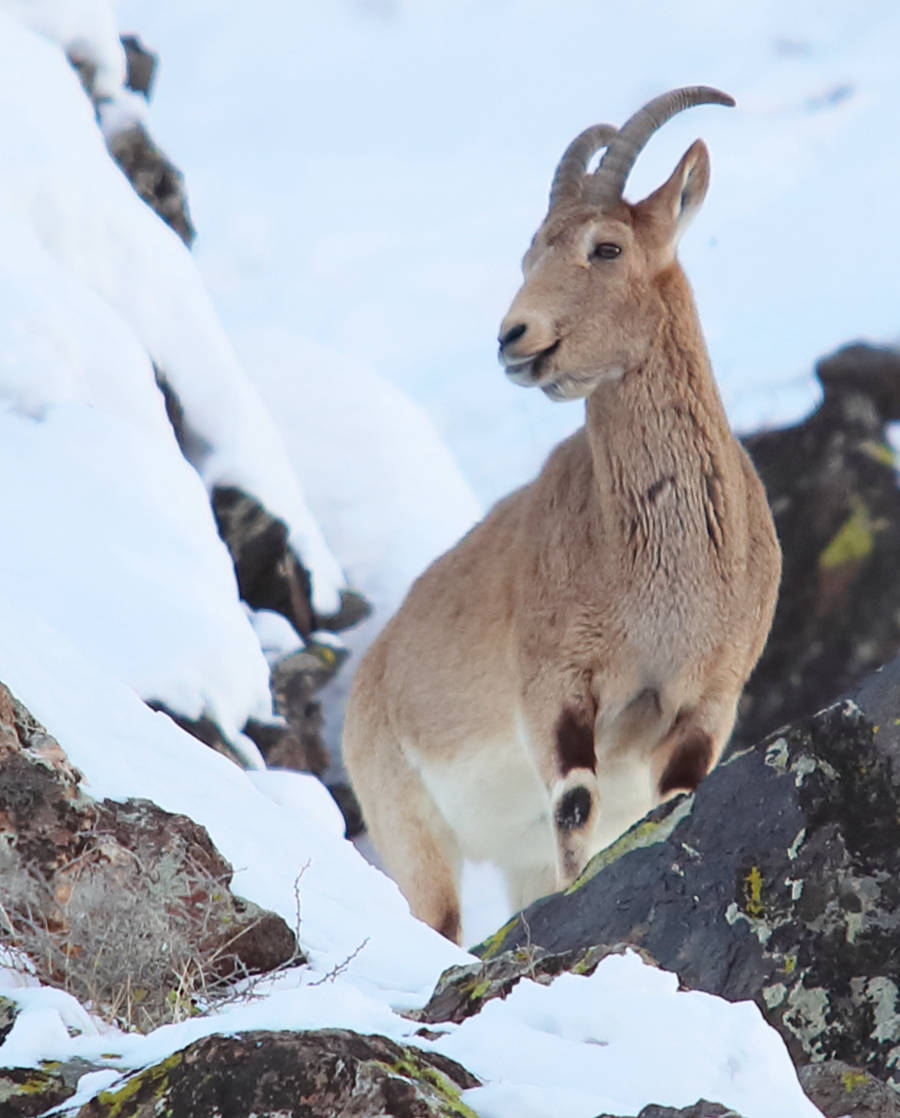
0, 595, 818, 1118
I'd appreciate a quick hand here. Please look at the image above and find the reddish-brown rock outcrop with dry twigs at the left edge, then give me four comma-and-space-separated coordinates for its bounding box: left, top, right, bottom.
0, 684, 302, 1025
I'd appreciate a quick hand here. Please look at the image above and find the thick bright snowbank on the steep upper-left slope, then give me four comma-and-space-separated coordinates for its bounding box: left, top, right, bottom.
0, 4, 344, 737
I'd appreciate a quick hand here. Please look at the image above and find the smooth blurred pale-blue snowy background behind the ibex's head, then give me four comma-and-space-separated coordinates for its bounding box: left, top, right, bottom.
120, 0, 900, 501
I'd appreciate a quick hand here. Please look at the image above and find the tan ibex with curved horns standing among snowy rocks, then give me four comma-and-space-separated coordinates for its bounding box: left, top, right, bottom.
343, 86, 780, 941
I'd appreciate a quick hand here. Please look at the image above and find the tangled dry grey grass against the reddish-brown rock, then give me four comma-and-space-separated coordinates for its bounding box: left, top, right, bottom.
0, 837, 296, 1032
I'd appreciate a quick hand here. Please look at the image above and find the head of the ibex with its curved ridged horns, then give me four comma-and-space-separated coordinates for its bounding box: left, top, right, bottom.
499, 86, 735, 399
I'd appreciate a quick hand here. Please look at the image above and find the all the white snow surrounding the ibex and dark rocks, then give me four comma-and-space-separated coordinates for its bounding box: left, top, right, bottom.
0, 0, 880, 1118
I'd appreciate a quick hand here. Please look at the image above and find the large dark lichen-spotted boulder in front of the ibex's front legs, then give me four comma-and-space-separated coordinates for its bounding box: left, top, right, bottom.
476, 660, 900, 1087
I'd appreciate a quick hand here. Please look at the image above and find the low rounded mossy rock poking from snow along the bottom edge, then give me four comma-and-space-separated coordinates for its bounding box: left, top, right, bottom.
78, 1029, 480, 1118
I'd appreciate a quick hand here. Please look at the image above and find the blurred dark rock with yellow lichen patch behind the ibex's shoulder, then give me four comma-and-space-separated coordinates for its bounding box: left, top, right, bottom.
732, 345, 900, 749
